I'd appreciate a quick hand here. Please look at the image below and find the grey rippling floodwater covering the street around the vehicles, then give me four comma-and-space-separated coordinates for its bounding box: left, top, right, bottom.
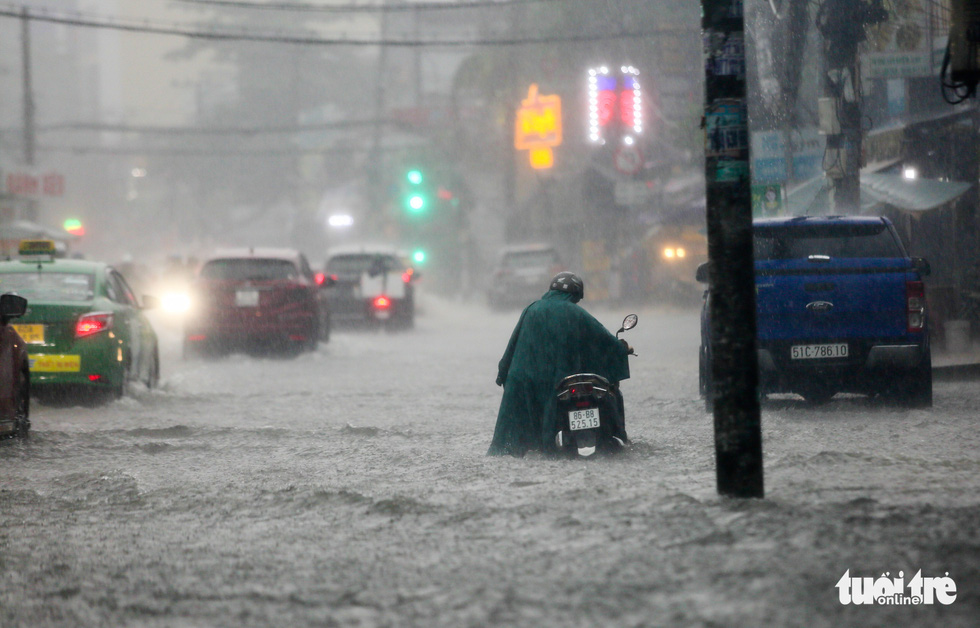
0, 299, 980, 627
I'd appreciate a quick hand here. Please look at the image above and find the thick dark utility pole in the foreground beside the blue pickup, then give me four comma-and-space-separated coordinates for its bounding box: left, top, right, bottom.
701, 0, 764, 497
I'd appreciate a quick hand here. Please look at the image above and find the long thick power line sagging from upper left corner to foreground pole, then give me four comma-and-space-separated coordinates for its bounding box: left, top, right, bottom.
0, 5, 698, 48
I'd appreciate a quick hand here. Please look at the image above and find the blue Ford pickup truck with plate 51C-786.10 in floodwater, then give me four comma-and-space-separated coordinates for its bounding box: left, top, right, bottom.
697, 216, 932, 407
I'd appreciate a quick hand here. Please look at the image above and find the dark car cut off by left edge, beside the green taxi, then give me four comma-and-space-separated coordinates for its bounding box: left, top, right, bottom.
0, 294, 31, 437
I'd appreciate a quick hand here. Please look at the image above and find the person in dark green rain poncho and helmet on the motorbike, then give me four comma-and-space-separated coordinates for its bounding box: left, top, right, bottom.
487, 271, 633, 457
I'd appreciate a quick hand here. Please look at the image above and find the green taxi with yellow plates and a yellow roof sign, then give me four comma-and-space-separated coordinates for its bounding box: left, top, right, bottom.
0, 240, 160, 397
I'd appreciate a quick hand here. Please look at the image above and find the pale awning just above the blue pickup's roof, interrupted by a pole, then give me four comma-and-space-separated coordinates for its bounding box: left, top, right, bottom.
786, 172, 971, 216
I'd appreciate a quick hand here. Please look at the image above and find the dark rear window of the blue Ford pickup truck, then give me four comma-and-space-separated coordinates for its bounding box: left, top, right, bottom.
752, 223, 905, 260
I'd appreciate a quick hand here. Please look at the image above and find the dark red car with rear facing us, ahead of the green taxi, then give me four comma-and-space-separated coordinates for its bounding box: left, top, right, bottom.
184, 248, 330, 357
